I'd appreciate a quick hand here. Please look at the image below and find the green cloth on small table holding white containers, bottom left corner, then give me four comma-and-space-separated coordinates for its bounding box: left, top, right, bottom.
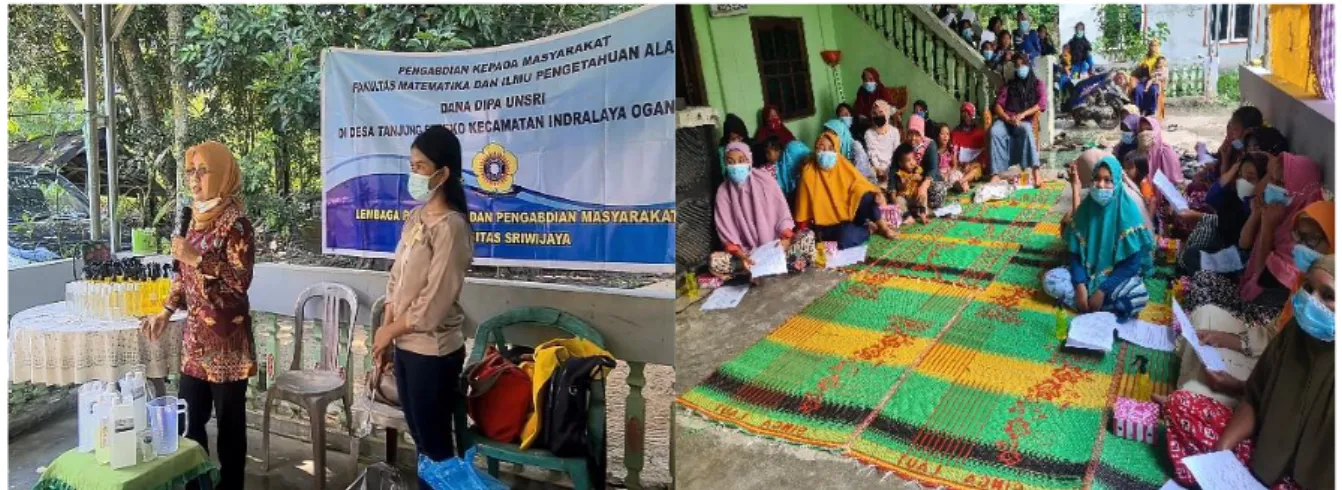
34, 438, 219, 490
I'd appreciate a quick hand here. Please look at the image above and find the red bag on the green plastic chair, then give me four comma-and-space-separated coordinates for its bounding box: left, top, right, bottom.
462, 346, 531, 443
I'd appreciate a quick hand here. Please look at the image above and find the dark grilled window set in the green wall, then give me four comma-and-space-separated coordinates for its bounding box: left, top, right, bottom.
750, 17, 816, 119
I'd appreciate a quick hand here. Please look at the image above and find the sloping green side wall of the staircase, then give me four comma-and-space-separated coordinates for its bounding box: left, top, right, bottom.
833, 5, 966, 131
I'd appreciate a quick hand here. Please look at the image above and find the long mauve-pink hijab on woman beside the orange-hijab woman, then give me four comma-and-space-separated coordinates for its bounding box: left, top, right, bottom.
713, 142, 794, 252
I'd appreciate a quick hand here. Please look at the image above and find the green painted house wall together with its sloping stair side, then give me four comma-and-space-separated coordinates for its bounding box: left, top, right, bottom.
691, 4, 982, 145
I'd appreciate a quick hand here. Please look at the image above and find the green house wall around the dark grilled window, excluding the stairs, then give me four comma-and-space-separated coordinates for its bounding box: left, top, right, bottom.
690, 4, 839, 145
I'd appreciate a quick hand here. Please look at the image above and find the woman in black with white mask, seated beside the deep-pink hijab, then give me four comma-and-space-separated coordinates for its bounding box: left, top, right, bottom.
1178, 153, 1268, 275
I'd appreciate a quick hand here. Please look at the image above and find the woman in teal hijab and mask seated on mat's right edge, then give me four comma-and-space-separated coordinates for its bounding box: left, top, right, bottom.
1044, 156, 1155, 321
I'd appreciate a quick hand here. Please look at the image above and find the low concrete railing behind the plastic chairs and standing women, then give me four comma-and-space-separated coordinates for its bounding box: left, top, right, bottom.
9, 260, 675, 489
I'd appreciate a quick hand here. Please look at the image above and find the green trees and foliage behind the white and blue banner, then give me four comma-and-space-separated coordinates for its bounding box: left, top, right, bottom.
8, 4, 638, 252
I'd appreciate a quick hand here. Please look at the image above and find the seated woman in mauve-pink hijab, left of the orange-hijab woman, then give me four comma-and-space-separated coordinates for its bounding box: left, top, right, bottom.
709, 142, 816, 279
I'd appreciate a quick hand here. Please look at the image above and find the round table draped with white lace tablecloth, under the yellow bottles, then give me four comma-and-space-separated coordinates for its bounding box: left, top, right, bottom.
9, 302, 187, 385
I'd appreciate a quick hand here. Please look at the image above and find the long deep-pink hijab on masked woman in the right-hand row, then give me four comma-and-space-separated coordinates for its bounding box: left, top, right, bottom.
1240, 153, 1323, 301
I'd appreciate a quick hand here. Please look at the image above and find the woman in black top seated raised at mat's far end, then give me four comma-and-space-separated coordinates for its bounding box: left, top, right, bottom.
988, 54, 1048, 185
